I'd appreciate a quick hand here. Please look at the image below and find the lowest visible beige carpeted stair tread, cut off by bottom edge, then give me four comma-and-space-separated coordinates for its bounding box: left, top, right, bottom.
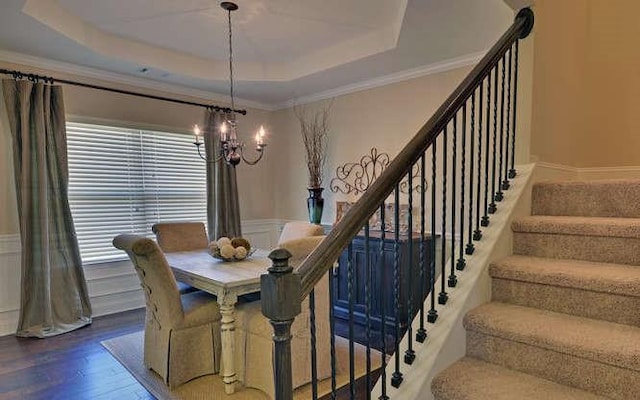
431, 357, 607, 400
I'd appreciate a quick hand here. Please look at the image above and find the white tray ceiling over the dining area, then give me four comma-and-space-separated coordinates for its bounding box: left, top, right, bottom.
0, 0, 513, 109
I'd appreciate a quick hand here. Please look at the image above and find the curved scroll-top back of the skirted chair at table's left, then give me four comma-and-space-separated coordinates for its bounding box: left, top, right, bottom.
113, 234, 184, 329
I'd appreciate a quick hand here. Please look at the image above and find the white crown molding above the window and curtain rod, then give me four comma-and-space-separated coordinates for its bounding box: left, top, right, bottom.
0, 50, 273, 111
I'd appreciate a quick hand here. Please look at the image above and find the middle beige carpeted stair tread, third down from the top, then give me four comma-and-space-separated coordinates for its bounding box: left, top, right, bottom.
489, 255, 640, 296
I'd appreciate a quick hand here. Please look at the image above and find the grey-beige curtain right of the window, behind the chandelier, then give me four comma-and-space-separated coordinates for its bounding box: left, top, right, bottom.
204, 110, 242, 240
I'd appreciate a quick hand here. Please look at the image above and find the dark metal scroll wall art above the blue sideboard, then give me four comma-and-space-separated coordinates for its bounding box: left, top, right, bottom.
329, 147, 427, 196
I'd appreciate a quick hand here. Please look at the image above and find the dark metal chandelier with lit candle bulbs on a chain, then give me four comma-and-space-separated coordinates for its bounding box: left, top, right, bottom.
193, 1, 267, 167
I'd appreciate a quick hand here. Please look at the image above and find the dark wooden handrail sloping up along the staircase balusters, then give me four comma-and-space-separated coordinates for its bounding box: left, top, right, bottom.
297, 8, 534, 299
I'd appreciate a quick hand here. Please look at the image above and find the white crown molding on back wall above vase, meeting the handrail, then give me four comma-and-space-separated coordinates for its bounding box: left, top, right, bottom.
274, 50, 487, 110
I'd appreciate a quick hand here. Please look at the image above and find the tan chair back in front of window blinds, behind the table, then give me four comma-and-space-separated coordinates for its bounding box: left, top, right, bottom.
151, 222, 209, 253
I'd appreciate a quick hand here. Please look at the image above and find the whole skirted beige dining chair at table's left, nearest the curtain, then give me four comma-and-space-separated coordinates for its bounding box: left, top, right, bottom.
113, 234, 221, 388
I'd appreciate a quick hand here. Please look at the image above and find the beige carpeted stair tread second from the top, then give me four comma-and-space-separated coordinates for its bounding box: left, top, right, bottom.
511, 215, 640, 239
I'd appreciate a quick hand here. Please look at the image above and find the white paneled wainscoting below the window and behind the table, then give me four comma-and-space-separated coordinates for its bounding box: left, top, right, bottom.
0, 219, 287, 336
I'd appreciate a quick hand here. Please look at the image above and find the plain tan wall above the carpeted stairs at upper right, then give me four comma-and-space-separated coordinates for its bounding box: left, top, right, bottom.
531, 0, 640, 167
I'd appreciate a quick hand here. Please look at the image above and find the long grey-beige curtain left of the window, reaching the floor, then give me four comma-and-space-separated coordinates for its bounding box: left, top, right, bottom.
2, 79, 91, 337
